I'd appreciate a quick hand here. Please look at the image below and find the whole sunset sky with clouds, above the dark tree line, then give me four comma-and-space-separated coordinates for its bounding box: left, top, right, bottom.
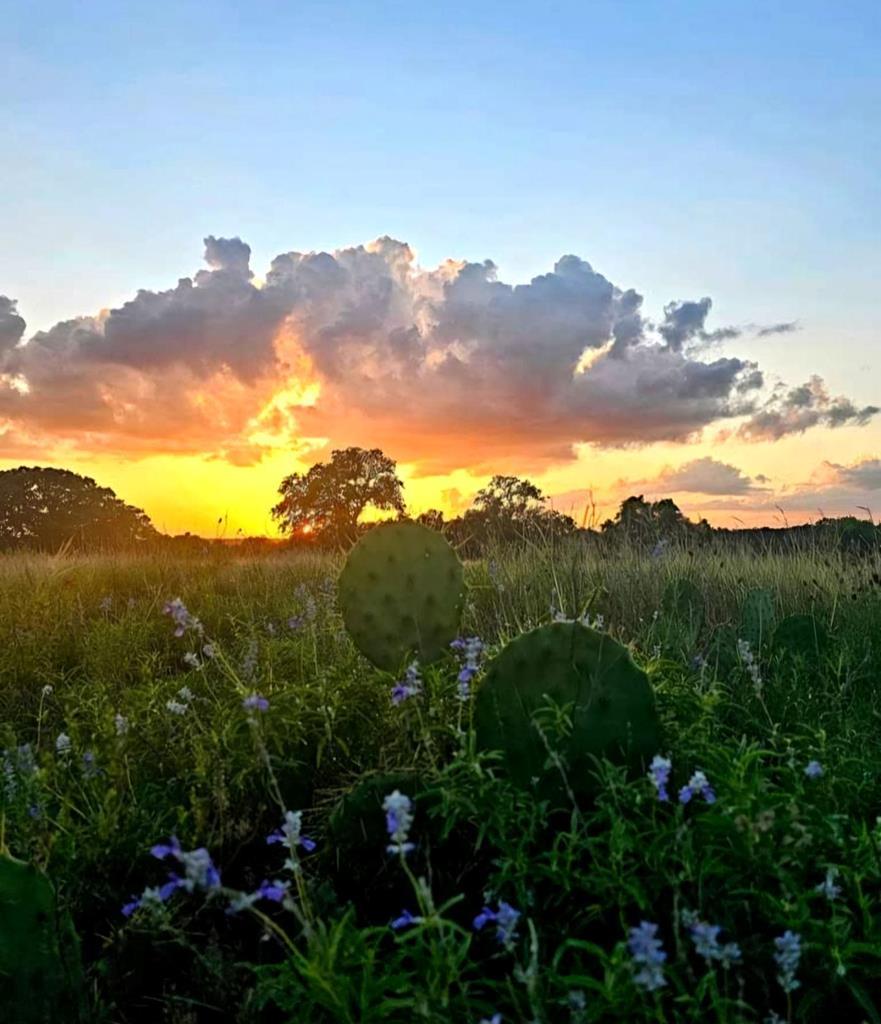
0, 0, 881, 536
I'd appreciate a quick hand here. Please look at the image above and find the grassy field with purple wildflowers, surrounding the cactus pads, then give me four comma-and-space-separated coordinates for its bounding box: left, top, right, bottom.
0, 542, 881, 1024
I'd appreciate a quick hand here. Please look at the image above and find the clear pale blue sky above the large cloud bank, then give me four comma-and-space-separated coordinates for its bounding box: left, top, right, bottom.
0, 0, 881, 528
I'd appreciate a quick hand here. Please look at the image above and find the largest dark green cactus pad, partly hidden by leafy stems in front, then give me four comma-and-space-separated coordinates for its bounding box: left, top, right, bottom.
474, 623, 660, 791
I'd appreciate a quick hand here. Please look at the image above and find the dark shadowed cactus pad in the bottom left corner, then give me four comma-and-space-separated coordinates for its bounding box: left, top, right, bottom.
0, 856, 82, 1024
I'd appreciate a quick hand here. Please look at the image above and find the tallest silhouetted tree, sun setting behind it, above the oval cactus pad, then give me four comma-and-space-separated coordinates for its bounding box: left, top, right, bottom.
272, 447, 405, 544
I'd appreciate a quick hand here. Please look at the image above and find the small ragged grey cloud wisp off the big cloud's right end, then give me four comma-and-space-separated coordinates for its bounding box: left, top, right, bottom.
739, 376, 881, 440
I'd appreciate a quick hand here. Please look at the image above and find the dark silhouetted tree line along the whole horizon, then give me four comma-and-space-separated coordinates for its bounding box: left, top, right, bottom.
0, 447, 881, 557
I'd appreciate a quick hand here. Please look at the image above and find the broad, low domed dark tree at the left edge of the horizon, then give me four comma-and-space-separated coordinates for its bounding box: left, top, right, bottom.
0, 466, 158, 551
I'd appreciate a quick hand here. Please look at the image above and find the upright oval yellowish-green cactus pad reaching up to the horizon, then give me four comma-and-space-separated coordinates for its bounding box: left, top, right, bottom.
339, 522, 465, 672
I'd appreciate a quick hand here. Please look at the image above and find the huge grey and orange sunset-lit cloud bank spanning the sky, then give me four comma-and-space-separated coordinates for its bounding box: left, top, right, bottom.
0, 236, 871, 473
